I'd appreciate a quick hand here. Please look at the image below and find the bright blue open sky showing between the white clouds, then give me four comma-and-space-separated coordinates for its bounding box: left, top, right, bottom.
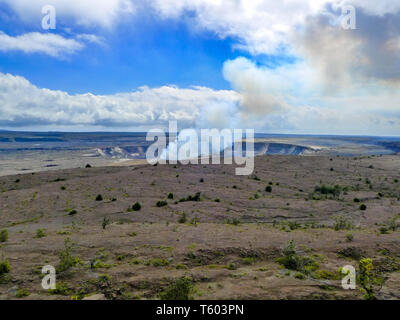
0, 6, 246, 94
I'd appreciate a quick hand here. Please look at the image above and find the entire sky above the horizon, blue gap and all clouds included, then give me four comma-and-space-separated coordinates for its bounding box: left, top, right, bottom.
0, 0, 400, 135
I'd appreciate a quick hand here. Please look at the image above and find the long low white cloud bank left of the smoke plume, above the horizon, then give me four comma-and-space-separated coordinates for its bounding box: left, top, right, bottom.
0, 73, 238, 130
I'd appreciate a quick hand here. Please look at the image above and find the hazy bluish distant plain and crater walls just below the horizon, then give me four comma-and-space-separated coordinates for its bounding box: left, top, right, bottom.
0, 131, 400, 175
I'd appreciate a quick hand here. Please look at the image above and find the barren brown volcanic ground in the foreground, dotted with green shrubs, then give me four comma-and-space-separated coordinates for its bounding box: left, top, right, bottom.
0, 156, 400, 299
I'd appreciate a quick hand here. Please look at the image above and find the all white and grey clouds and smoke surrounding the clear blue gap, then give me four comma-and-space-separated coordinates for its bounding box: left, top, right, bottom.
0, 0, 400, 135
